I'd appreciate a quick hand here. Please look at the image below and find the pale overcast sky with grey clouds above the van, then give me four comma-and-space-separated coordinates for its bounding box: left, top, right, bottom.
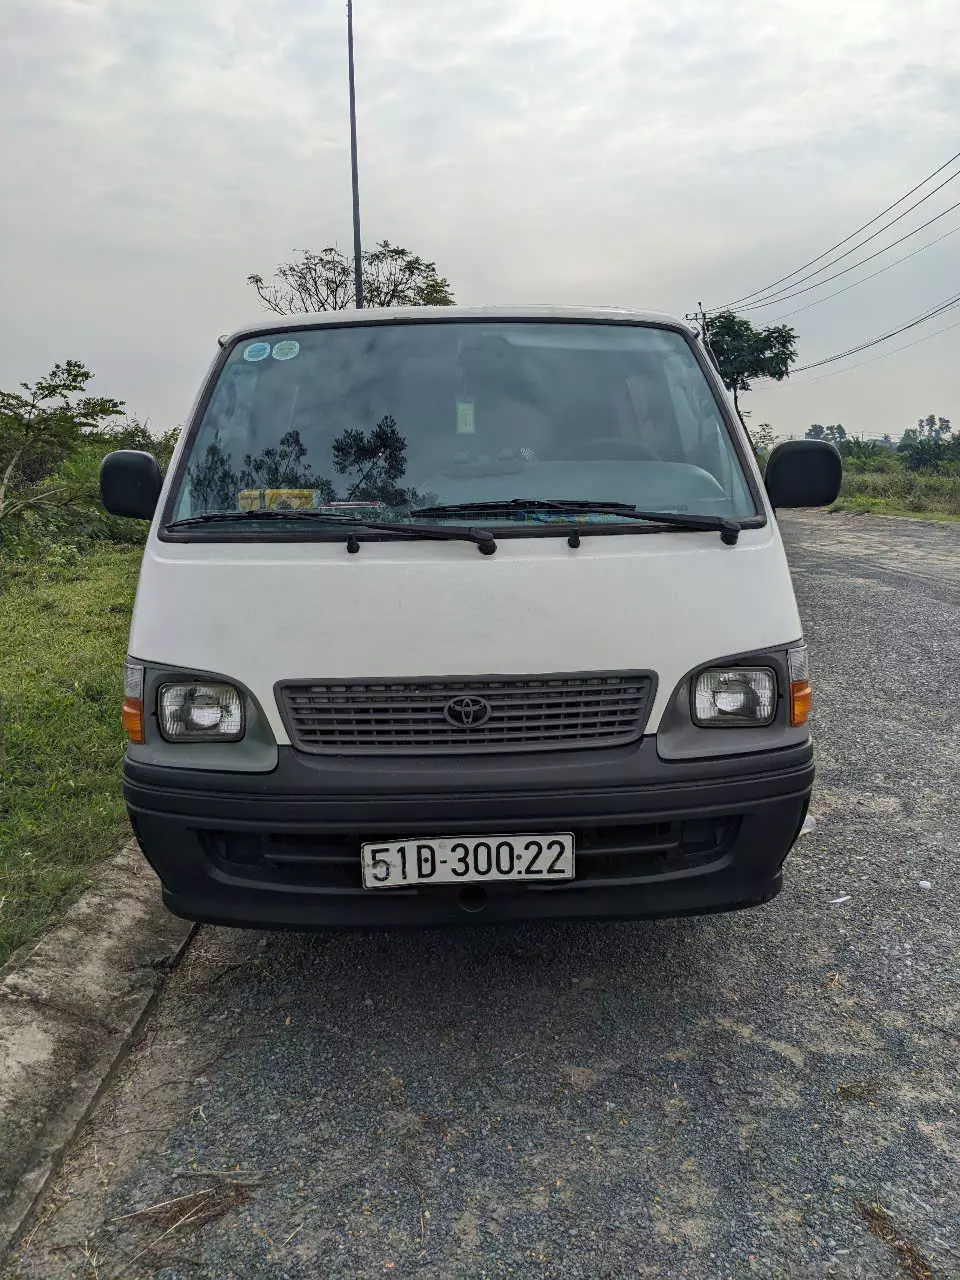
0, 0, 960, 435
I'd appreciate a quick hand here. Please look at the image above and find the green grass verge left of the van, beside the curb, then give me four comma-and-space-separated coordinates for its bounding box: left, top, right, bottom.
0, 547, 141, 964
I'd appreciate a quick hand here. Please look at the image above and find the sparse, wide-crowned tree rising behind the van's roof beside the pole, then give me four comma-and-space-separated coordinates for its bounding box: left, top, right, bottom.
247, 241, 453, 316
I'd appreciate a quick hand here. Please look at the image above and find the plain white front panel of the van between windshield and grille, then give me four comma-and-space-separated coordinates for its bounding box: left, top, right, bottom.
131, 521, 800, 744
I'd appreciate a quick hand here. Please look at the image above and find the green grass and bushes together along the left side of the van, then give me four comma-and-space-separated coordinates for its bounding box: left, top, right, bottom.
0, 361, 177, 964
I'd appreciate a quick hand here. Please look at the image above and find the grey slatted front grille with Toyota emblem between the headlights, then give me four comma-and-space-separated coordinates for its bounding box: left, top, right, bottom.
276, 671, 655, 755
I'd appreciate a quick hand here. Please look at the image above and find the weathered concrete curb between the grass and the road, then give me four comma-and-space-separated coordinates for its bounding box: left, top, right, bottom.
0, 842, 196, 1258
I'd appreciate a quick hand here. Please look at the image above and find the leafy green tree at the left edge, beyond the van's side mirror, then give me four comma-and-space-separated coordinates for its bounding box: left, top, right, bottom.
0, 360, 123, 521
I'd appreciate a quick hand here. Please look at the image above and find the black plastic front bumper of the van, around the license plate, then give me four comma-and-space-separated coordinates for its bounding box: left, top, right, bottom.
124, 736, 814, 929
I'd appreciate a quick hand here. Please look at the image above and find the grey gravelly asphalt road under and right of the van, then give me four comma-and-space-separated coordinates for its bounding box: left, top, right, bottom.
5, 515, 960, 1280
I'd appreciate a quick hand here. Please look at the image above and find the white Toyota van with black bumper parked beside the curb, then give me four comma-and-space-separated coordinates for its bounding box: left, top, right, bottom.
101, 307, 841, 928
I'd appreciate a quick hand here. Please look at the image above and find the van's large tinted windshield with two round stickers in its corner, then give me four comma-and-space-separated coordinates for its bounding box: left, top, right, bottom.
170, 321, 756, 527
